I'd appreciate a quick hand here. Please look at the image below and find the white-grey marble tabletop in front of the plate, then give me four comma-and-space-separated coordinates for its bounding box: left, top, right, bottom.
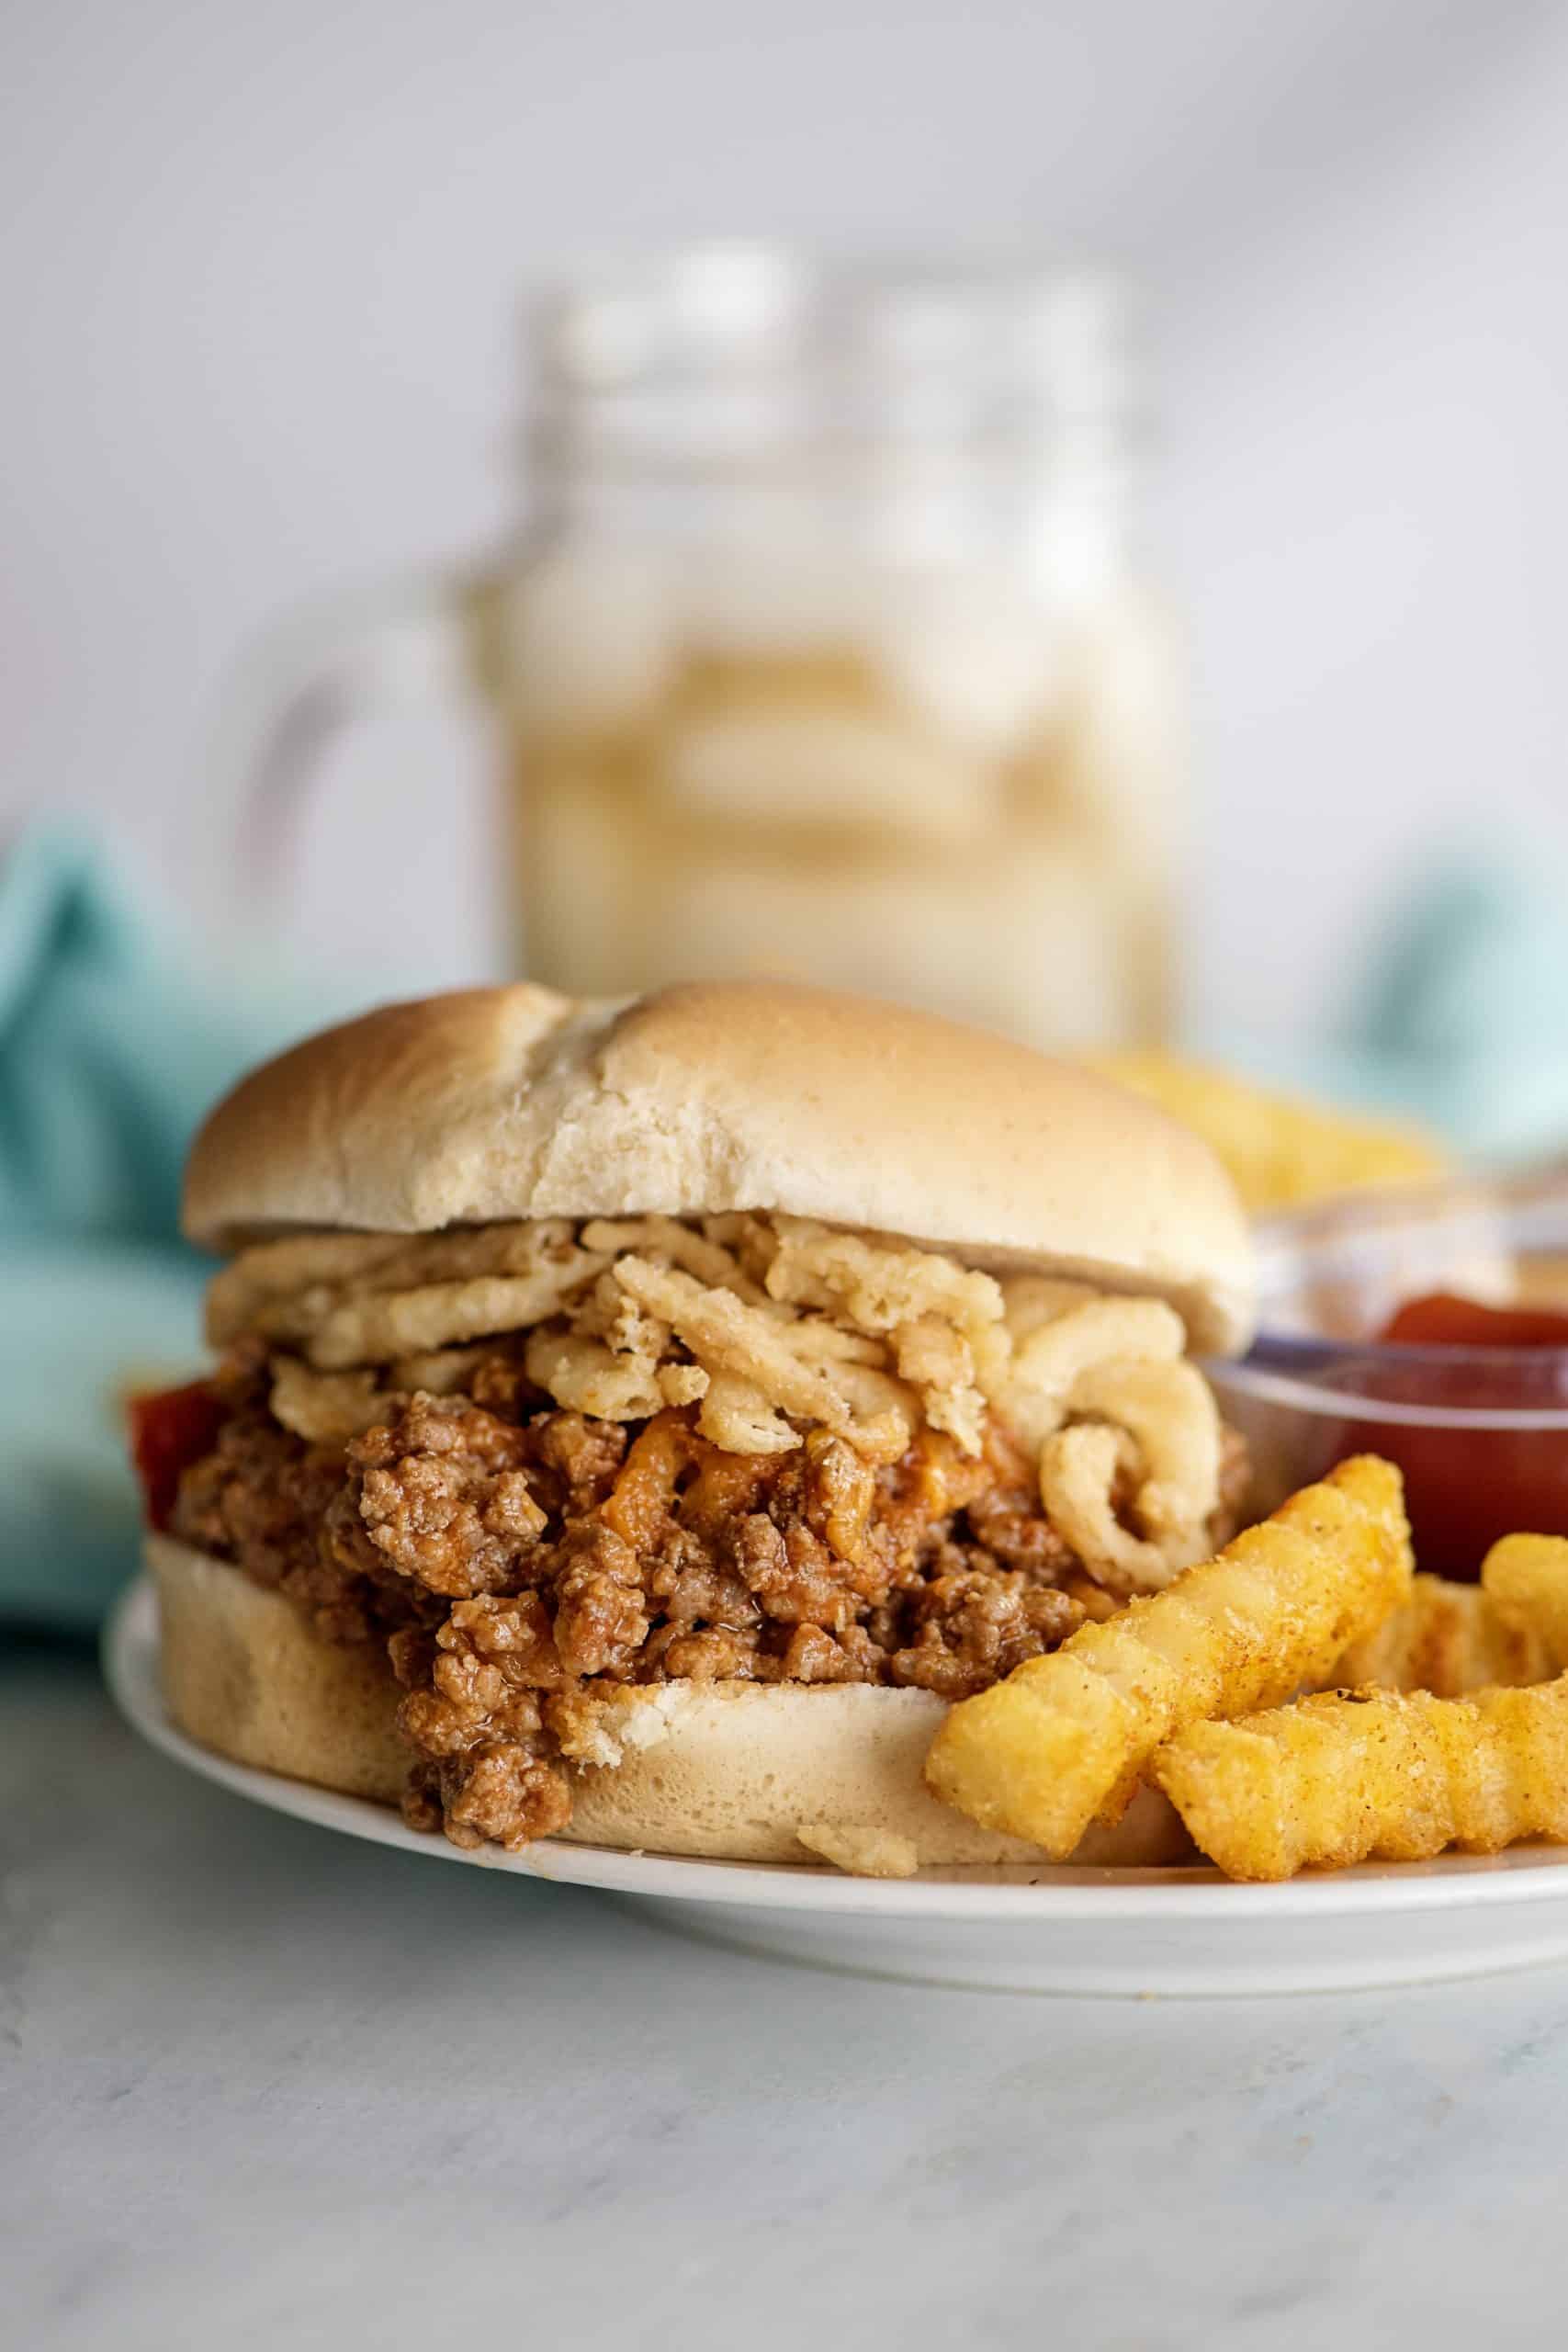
0, 1656, 1568, 2352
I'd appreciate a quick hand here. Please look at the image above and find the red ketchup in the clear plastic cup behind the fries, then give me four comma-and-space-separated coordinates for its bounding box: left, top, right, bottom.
1347, 1291, 1568, 1580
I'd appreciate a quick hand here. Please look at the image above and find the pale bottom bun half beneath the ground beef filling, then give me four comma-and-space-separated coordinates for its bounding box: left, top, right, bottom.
148, 1536, 1192, 1868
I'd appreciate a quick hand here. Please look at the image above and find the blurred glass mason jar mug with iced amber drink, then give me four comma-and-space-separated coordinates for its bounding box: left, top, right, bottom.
220, 247, 1185, 1046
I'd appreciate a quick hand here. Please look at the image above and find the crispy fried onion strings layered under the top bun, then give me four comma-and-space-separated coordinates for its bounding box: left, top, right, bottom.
226, 1214, 1220, 1595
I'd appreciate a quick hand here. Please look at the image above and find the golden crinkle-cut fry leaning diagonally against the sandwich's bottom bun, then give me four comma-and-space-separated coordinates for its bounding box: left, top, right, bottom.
926, 1453, 1411, 1860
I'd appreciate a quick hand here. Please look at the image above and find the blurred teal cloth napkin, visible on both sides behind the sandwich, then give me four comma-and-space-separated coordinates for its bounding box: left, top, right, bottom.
0, 831, 1568, 1633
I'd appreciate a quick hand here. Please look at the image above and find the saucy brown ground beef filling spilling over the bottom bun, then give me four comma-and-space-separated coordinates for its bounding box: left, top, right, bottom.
172, 1352, 1246, 1847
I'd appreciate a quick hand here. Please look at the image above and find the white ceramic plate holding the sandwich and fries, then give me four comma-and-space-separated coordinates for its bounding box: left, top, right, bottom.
104, 1580, 1568, 1995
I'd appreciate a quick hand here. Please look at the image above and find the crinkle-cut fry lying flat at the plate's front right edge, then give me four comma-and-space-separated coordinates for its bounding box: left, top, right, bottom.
1149, 1677, 1568, 1879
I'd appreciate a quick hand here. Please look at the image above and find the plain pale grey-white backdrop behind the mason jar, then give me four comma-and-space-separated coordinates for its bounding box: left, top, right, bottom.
0, 0, 1568, 1030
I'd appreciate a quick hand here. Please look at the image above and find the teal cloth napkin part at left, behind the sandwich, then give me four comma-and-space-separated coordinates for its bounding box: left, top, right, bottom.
0, 828, 359, 1633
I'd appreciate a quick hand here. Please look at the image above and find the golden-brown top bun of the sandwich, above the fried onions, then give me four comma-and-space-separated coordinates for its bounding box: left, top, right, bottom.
184, 981, 1253, 1352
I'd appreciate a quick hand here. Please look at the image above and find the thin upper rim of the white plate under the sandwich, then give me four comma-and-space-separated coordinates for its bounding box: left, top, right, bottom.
98, 1574, 1568, 1927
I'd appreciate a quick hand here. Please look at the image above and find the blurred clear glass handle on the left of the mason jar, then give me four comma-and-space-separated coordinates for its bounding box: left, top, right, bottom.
205, 570, 475, 908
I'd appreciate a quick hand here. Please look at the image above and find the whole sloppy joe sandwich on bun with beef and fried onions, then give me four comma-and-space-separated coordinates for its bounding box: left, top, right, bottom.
136, 983, 1251, 1870
